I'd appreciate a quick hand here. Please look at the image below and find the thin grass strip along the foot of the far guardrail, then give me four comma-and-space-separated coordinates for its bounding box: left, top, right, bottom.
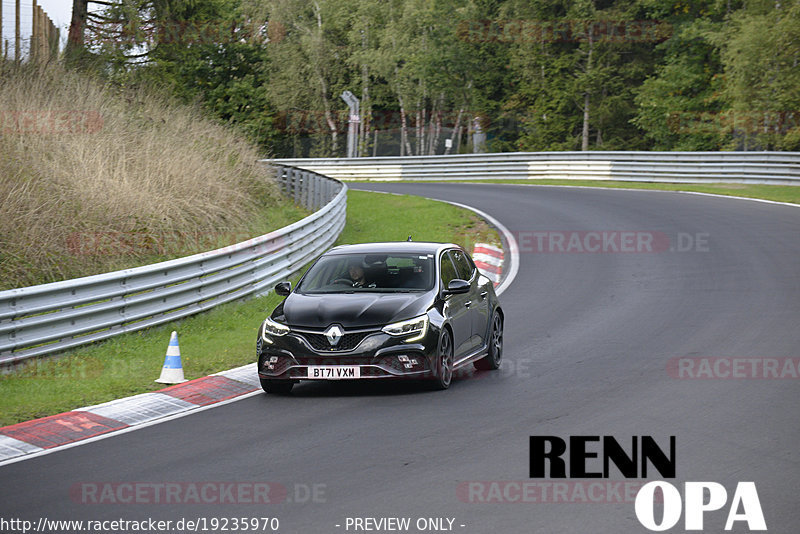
362, 179, 800, 204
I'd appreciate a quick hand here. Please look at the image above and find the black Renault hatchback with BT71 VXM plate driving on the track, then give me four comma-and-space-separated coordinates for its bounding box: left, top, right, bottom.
256, 242, 503, 394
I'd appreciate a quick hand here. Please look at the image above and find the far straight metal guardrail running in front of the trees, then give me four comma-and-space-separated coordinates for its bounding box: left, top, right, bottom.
274, 152, 800, 185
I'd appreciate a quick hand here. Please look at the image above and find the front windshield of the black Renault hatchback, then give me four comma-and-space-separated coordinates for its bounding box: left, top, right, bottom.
297, 253, 435, 293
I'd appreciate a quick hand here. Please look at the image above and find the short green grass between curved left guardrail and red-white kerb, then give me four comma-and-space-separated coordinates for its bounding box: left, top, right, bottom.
0, 191, 500, 426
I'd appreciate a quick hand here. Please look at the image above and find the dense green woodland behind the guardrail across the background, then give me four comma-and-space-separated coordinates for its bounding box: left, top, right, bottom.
67, 0, 800, 156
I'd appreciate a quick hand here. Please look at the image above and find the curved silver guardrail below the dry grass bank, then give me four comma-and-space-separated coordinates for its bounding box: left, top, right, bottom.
0, 165, 347, 364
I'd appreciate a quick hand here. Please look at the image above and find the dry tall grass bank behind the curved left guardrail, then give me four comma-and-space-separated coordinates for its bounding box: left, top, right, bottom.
0, 65, 300, 289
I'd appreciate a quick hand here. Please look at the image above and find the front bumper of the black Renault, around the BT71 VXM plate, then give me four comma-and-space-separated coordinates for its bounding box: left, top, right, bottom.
257, 328, 439, 380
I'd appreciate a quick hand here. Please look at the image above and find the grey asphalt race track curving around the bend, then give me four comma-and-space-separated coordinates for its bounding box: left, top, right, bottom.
0, 184, 800, 534
